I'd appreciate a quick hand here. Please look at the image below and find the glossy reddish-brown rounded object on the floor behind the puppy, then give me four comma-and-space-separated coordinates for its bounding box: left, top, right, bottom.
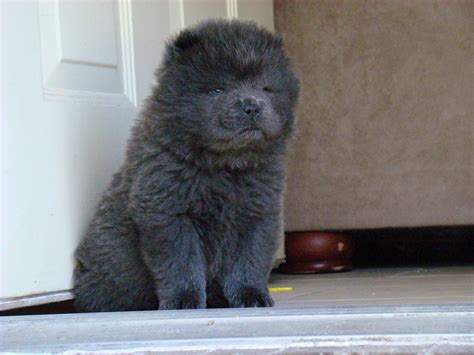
279, 232, 354, 274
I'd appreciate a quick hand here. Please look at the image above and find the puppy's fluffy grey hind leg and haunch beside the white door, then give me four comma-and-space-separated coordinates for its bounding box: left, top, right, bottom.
73, 204, 158, 312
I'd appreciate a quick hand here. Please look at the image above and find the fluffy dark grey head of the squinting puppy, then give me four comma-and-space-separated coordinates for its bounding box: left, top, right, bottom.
156, 21, 298, 153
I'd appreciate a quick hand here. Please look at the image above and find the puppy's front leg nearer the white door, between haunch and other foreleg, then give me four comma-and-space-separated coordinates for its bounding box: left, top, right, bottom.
142, 217, 206, 309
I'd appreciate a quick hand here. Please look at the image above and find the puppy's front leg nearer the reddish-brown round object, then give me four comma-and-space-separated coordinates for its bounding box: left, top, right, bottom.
224, 218, 279, 307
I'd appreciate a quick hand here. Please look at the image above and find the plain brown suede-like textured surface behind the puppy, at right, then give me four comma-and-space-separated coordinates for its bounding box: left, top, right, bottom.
274, 0, 474, 230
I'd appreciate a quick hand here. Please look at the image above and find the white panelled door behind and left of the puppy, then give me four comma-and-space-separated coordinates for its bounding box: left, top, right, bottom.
0, 0, 273, 303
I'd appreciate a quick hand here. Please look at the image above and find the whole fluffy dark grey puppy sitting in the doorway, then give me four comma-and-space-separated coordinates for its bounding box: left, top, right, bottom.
74, 21, 298, 311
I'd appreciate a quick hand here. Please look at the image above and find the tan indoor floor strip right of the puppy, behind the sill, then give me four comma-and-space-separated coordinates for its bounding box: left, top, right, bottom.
270, 265, 474, 307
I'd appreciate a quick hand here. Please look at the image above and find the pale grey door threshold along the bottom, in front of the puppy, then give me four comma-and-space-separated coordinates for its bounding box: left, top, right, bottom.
0, 304, 474, 354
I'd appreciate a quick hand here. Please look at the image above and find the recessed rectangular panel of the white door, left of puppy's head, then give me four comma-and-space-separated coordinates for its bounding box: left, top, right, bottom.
38, 0, 137, 105
